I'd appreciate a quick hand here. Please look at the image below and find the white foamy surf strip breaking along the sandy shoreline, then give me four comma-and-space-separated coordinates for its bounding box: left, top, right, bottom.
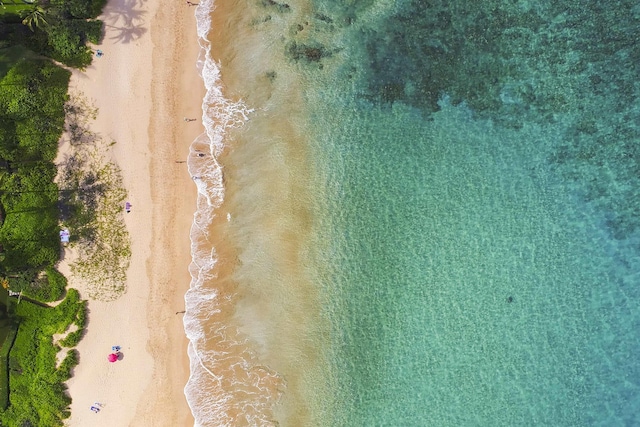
184, 0, 279, 427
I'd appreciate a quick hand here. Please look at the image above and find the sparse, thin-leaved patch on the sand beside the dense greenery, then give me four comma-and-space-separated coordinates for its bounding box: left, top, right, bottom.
59, 96, 131, 301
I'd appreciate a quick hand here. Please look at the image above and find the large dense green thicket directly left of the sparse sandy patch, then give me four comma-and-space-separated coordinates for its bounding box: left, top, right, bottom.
0, 61, 70, 280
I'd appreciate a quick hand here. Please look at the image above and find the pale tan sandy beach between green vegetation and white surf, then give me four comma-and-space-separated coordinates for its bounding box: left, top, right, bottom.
60, 0, 204, 427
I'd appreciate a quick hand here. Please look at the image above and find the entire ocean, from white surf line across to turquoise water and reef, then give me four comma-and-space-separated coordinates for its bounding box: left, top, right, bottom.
185, 0, 640, 427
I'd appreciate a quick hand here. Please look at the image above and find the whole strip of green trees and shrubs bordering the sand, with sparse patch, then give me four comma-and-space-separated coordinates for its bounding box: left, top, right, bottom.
0, 0, 110, 427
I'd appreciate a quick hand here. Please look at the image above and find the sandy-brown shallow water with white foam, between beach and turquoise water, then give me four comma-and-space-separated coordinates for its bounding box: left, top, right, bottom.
185, 1, 336, 426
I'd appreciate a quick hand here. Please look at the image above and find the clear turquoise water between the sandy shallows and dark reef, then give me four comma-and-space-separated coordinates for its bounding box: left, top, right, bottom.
312, 98, 639, 426
